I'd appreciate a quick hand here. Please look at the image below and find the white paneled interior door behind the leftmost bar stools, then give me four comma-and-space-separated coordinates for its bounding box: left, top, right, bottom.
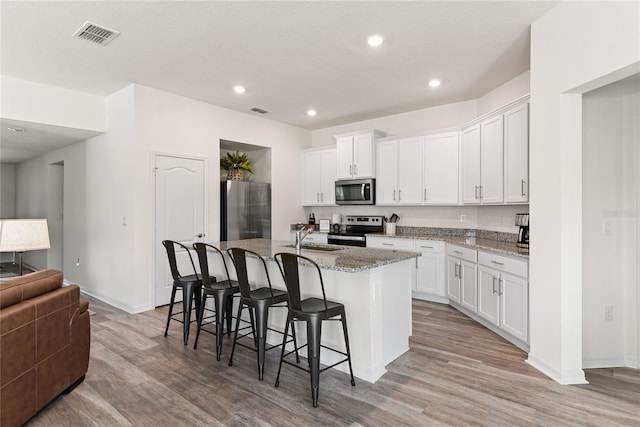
154, 155, 206, 307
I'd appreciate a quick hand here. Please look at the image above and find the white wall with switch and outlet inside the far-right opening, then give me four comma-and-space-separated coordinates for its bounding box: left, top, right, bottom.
582, 79, 640, 368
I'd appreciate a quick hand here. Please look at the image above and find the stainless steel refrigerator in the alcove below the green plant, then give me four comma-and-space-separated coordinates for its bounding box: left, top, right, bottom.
220, 181, 271, 241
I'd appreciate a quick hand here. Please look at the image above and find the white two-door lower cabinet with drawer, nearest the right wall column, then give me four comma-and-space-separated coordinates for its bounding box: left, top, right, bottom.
478, 251, 529, 343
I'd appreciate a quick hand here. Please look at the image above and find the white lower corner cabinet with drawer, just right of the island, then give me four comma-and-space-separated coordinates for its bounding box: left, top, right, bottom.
414, 240, 446, 302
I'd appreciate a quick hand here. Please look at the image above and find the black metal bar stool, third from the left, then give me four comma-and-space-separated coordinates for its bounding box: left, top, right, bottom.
227, 248, 299, 381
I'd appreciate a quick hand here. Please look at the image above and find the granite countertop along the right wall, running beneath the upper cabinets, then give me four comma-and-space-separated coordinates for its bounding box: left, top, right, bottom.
367, 231, 529, 259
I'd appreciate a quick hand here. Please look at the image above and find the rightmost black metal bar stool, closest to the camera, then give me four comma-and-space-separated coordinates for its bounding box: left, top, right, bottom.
274, 252, 356, 408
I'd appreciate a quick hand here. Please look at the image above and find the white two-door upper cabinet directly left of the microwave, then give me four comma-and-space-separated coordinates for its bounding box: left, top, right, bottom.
302, 148, 336, 206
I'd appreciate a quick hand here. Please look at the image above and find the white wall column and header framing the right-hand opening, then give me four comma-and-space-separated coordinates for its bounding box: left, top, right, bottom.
528, 2, 640, 383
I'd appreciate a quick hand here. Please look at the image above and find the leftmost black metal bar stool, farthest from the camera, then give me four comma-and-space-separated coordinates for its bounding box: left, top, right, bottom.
162, 240, 208, 345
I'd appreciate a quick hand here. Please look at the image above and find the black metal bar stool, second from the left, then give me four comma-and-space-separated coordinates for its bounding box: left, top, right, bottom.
193, 242, 240, 360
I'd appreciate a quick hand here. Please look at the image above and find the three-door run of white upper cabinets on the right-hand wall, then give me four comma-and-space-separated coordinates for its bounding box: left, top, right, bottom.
462, 102, 529, 204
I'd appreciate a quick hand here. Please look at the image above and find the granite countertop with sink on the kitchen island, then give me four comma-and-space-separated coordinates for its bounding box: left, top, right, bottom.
214, 239, 419, 273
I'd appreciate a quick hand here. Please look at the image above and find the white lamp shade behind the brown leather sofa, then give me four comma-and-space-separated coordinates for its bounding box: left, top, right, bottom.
0, 219, 51, 252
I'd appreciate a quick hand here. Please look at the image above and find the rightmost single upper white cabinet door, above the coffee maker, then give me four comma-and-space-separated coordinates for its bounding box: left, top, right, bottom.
504, 102, 529, 203
